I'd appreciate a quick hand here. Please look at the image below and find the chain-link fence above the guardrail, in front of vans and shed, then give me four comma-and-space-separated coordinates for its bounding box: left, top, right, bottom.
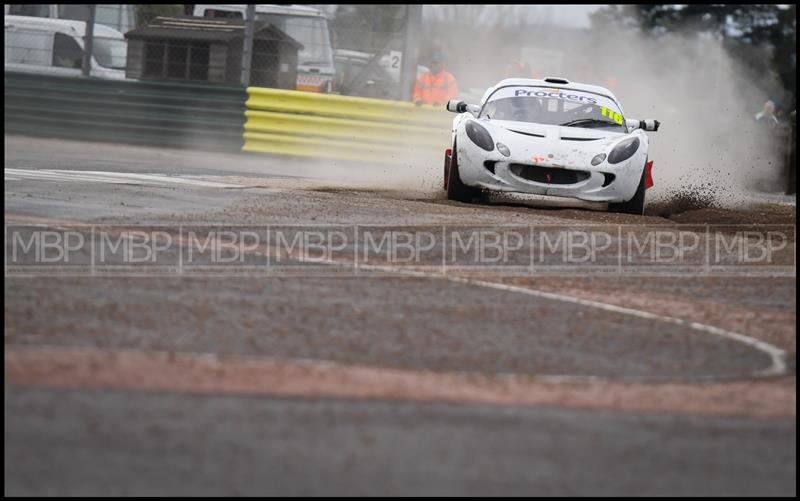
5, 4, 424, 99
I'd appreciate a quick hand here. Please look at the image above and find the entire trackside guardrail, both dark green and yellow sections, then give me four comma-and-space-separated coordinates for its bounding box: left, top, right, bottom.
3, 71, 452, 164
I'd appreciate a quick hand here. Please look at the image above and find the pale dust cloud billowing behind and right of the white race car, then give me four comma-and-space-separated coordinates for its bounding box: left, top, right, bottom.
432, 12, 785, 209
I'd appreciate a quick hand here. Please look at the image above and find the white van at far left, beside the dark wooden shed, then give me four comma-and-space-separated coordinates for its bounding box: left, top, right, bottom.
3, 16, 128, 79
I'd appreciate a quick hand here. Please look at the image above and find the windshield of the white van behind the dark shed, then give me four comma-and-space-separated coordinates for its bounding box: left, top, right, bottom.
256, 14, 333, 67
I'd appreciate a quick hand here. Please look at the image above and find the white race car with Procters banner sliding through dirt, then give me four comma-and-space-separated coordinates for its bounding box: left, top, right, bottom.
444, 78, 659, 214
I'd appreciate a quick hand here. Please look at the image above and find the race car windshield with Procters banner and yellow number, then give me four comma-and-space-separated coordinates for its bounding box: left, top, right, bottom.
480, 87, 627, 133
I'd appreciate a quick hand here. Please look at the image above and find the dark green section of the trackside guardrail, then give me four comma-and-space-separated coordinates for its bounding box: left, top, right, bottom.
3, 71, 247, 151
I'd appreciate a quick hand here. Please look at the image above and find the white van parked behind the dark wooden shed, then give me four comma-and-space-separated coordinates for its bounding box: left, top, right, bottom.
194, 4, 336, 92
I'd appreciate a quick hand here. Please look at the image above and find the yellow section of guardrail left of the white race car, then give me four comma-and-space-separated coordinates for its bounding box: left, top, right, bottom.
242, 87, 453, 164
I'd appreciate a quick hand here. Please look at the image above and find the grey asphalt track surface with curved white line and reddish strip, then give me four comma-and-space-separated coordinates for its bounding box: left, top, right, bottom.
5, 136, 796, 495
